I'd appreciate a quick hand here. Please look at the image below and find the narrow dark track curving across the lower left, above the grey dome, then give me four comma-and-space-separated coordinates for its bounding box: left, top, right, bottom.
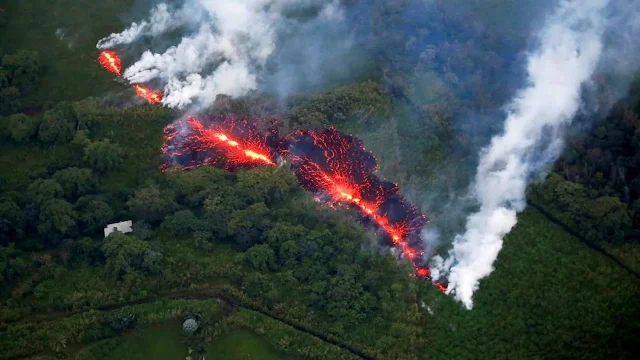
1, 290, 375, 360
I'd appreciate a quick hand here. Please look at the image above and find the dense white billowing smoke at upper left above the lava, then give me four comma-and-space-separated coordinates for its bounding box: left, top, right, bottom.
97, 0, 341, 108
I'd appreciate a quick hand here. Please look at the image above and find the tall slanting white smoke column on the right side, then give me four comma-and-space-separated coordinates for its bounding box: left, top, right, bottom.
432, 0, 609, 309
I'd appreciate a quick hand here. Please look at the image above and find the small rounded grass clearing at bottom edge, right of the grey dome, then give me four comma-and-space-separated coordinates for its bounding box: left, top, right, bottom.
207, 330, 284, 360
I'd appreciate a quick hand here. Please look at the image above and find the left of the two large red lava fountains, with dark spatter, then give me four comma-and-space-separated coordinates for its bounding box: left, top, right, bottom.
162, 116, 277, 170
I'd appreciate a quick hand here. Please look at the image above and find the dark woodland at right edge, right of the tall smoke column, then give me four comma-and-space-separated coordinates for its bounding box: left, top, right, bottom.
531, 82, 640, 245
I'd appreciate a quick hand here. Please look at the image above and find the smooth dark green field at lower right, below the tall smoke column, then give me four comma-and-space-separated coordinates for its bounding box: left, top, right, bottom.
425, 208, 640, 359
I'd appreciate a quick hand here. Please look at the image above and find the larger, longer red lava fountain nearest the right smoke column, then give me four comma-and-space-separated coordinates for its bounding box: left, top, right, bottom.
282, 128, 428, 277
